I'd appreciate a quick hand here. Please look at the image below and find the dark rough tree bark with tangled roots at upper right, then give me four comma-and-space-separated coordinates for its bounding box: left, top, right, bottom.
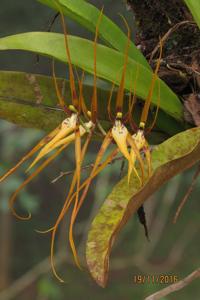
127, 0, 200, 126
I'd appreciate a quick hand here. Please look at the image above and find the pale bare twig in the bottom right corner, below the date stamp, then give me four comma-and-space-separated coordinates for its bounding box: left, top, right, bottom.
145, 268, 200, 300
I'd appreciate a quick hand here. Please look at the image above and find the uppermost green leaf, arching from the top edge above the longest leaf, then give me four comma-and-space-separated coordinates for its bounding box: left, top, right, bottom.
38, 0, 150, 69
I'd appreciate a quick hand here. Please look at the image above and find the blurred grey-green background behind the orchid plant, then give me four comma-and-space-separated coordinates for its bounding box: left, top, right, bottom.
0, 0, 200, 300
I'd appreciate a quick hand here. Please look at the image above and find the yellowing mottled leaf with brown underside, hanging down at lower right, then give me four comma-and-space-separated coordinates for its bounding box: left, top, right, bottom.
86, 128, 200, 287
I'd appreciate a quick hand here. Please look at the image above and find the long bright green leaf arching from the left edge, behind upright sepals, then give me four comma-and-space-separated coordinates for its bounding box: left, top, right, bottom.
0, 32, 183, 122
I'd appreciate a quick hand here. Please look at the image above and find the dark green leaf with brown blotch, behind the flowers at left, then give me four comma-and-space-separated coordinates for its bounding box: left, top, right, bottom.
0, 71, 108, 131
